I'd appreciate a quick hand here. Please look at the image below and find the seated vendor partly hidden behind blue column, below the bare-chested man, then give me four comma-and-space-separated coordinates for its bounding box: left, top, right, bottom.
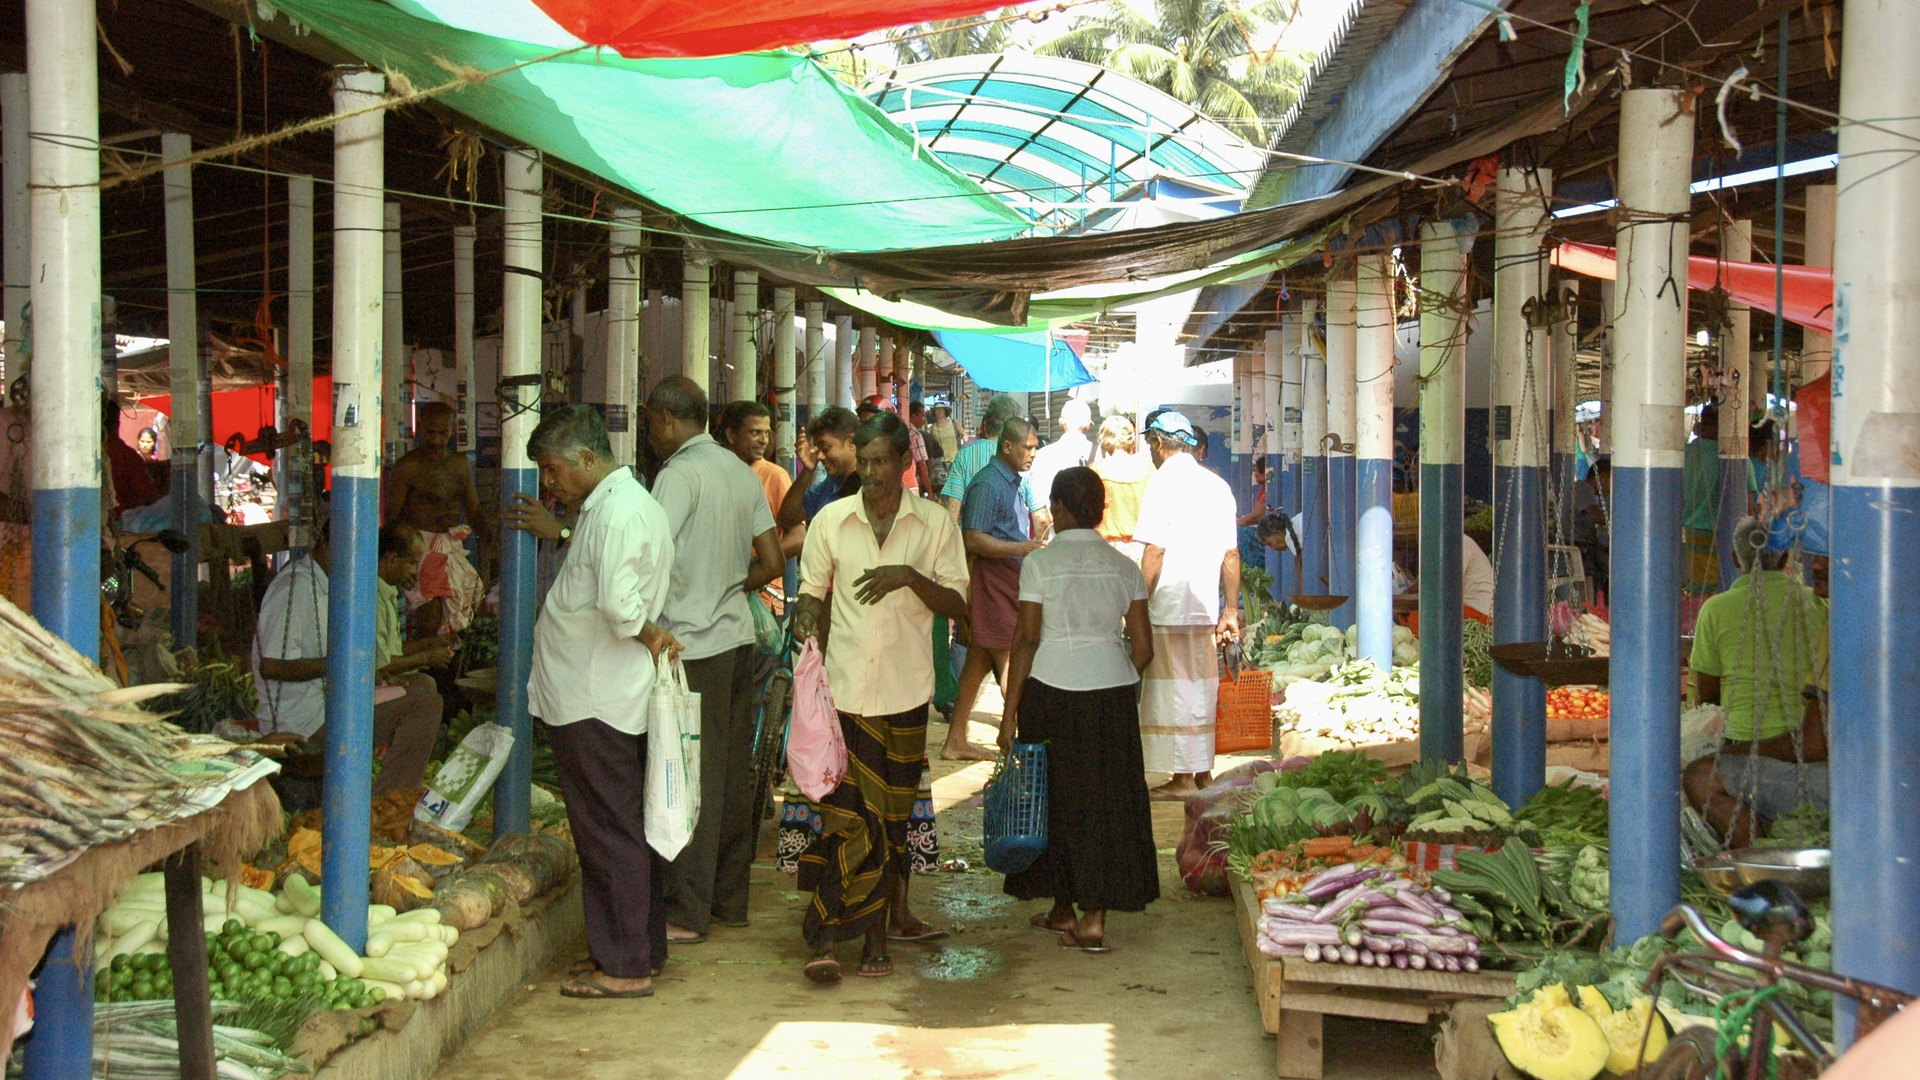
252, 527, 451, 796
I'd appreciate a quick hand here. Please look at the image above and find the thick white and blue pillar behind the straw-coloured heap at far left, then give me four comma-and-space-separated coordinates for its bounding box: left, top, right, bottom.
23, 0, 98, 1060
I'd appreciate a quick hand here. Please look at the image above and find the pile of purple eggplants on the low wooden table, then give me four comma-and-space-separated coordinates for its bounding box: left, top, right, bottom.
1260, 863, 1480, 972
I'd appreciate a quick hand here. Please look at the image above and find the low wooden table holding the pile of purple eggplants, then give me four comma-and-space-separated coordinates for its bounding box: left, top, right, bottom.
1233, 880, 1513, 1080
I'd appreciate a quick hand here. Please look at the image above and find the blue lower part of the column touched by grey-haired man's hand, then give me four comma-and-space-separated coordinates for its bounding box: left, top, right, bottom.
493, 469, 540, 836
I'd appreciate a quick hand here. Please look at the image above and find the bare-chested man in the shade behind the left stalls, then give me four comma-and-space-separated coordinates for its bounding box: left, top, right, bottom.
384, 402, 486, 634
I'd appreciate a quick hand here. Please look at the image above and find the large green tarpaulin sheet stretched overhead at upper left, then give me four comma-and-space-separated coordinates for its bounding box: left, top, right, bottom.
275, 0, 1027, 252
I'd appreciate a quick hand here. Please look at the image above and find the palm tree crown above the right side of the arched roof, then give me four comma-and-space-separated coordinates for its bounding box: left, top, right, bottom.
1035, 0, 1309, 142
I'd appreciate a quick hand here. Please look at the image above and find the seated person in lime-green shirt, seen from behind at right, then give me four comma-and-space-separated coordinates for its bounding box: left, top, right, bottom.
1682, 517, 1828, 847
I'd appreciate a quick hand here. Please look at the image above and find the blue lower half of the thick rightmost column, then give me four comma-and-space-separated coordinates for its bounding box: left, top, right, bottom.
1820, 480, 1920, 1036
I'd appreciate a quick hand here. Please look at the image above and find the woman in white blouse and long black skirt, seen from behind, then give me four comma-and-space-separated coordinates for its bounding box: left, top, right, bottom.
1000, 469, 1160, 953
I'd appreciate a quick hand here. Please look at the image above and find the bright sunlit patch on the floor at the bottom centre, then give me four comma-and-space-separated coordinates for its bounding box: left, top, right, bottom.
728, 1020, 1114, 1080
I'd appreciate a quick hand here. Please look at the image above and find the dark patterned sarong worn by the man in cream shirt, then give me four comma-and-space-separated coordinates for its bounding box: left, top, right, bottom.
797, 705, 927, 949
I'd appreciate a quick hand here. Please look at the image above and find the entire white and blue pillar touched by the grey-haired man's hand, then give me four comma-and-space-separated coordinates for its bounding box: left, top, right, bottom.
493, 150, 545, 836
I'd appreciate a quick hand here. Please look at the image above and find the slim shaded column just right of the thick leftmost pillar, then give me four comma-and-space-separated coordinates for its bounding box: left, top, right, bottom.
160, 133, 207, 648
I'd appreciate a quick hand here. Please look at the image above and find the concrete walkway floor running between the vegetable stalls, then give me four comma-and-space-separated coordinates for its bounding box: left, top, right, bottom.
424, 688, 1434, 1080
